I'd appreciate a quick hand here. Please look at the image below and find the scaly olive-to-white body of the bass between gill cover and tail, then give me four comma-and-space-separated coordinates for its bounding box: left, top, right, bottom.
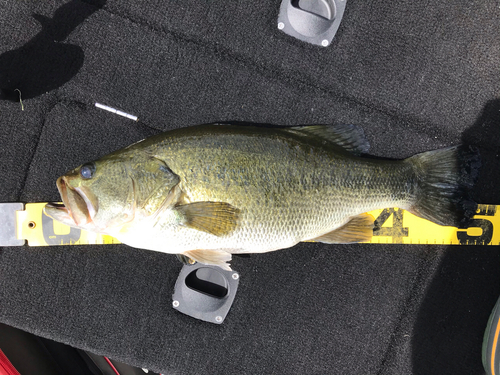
129, 126, 413, 252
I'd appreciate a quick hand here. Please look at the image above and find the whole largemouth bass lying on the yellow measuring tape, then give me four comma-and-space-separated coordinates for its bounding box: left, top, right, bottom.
45, 124, 479, 268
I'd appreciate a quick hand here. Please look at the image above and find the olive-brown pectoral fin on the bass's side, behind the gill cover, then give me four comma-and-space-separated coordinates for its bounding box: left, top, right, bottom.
176, 202, 240, 237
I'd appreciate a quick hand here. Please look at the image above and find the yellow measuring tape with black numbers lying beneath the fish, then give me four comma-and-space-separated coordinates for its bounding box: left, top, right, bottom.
8, 203, 500, 246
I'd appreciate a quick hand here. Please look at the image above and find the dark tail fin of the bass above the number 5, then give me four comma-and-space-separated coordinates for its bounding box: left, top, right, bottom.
406, 146, 481, 226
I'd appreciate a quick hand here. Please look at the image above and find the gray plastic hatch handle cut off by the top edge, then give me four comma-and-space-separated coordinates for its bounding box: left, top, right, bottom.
278, 0, 346, 47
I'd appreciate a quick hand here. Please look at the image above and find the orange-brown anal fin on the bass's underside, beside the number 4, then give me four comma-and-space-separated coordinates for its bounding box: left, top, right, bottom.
312, 214, 375, 243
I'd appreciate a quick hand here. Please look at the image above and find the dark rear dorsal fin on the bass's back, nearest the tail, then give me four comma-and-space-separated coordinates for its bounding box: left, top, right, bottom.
289, 124, 370, 155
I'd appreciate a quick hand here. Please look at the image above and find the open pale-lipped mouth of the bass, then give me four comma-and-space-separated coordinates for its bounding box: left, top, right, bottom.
55, 176, 96, 226
